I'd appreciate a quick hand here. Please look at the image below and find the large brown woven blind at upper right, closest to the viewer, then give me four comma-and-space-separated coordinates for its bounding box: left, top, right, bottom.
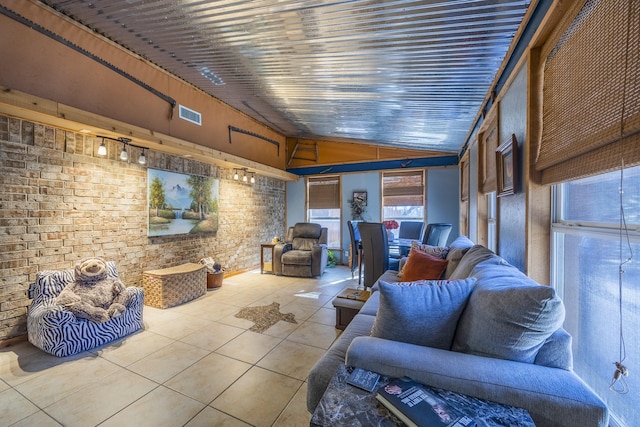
535, 0, 640, 184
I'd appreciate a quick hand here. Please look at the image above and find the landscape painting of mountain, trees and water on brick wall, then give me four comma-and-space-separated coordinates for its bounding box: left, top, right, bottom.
147, 169, 220, 236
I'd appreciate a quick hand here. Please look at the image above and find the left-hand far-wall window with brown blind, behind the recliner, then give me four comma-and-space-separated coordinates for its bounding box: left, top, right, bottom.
307, 176, 341, 249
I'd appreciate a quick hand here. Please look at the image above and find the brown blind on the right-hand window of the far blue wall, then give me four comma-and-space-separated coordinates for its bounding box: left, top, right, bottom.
382, 170, 424, 206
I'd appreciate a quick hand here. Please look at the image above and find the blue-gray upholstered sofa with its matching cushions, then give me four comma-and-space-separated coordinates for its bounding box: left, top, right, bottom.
307, 237, 609, 427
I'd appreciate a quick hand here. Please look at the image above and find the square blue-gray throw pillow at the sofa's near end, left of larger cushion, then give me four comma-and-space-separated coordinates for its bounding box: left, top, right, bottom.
371, 278, 475, 350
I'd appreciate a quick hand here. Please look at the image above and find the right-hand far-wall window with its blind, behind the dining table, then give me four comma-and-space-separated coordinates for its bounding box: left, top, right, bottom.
382, 170, 425, 237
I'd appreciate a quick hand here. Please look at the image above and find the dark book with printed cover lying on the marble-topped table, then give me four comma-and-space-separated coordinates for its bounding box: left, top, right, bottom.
376, 378, 475, 427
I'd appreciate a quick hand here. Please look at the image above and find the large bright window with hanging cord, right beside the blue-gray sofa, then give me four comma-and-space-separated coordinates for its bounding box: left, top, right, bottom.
552, 167, 640, 426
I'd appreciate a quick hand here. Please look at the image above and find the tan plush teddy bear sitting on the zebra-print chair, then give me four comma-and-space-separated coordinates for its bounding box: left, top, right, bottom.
56, 257, 130, 323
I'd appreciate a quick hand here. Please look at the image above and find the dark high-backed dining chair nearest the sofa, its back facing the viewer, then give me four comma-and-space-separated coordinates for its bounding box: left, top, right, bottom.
358, 222, 398, 289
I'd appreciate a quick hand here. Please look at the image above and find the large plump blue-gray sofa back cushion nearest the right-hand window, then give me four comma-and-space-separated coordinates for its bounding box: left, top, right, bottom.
452, 258, 565, 363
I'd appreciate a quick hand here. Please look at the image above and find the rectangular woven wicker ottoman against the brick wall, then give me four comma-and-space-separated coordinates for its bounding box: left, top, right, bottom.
142, 263, 207, 308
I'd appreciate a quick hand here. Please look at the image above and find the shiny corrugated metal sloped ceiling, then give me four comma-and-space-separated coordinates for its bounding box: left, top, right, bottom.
42, 0, 531, 153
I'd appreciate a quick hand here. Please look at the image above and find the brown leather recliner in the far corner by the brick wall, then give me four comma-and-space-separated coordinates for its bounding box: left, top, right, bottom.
273, 222, 329, 277
